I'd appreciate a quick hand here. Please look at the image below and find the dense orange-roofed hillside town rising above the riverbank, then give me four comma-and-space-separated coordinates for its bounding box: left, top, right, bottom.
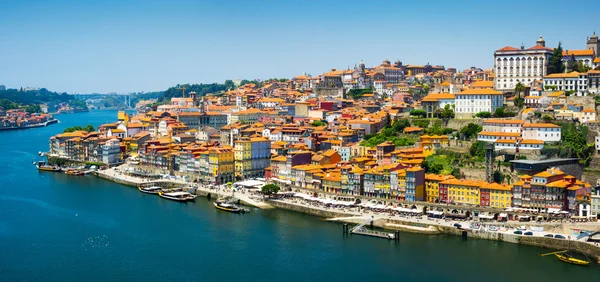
38, 33, 600, 265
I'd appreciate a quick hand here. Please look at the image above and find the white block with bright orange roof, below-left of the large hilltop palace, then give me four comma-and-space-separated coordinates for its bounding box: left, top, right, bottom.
454, 89, 504, 117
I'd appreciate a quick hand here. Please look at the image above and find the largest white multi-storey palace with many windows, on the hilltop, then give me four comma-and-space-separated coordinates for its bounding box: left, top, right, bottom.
494, 36, 553, 91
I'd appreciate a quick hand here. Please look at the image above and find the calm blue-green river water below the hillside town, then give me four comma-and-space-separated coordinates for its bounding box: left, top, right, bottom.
0, 111, 600, 282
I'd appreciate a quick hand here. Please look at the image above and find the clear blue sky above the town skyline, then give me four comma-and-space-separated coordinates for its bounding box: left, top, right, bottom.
0, 0, 600, 93
